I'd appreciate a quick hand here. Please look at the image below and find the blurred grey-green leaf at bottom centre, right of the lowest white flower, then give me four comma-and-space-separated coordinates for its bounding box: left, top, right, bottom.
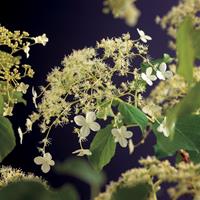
56, 158, 105, 187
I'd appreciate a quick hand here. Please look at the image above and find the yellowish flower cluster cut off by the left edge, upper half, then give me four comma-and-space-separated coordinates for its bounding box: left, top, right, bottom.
0, 26, 48, 116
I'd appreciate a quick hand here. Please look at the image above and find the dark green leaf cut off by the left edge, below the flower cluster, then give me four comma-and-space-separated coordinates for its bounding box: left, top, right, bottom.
0, 116, 16, 162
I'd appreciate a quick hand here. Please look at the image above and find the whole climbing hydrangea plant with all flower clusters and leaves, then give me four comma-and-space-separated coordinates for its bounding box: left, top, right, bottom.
0, 0, 200, 200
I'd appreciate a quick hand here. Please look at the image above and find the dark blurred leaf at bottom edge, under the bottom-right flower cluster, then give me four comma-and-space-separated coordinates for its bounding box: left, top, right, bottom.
111, 183, 152, 200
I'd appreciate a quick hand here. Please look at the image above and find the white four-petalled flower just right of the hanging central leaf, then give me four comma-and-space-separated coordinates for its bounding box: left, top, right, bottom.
111, 126, 133, 147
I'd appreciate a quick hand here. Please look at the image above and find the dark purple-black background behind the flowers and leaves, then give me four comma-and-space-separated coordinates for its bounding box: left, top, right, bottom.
0, 0, 177, 200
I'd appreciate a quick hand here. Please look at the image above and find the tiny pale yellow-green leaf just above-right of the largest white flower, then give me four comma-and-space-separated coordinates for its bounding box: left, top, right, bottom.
97, 100, 114, 120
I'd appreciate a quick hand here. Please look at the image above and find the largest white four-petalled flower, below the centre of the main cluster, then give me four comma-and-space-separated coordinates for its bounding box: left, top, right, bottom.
74, 112, 101, 139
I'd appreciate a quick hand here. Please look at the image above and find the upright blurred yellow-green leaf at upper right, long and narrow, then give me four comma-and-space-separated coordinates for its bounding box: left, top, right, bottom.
176, 17, 195, 82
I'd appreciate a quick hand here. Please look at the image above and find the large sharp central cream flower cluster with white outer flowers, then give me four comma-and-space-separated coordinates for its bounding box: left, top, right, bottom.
23, 29, 172, 171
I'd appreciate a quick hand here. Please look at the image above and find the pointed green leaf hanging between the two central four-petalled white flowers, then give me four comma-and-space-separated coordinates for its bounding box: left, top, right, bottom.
88, 125, 116, 171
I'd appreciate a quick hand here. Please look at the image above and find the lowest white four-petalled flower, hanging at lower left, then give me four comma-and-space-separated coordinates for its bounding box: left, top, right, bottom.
34, 153, 55, 173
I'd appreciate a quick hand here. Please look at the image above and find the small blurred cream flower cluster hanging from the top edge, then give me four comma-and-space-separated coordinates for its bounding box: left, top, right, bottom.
103, 0, 140, 26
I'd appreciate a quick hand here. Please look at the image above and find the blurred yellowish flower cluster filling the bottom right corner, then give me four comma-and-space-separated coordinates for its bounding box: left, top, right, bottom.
95, 157, 200, 200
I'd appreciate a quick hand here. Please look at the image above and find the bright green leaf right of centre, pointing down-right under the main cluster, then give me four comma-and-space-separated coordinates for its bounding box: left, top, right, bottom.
118, 102, 148, 131
